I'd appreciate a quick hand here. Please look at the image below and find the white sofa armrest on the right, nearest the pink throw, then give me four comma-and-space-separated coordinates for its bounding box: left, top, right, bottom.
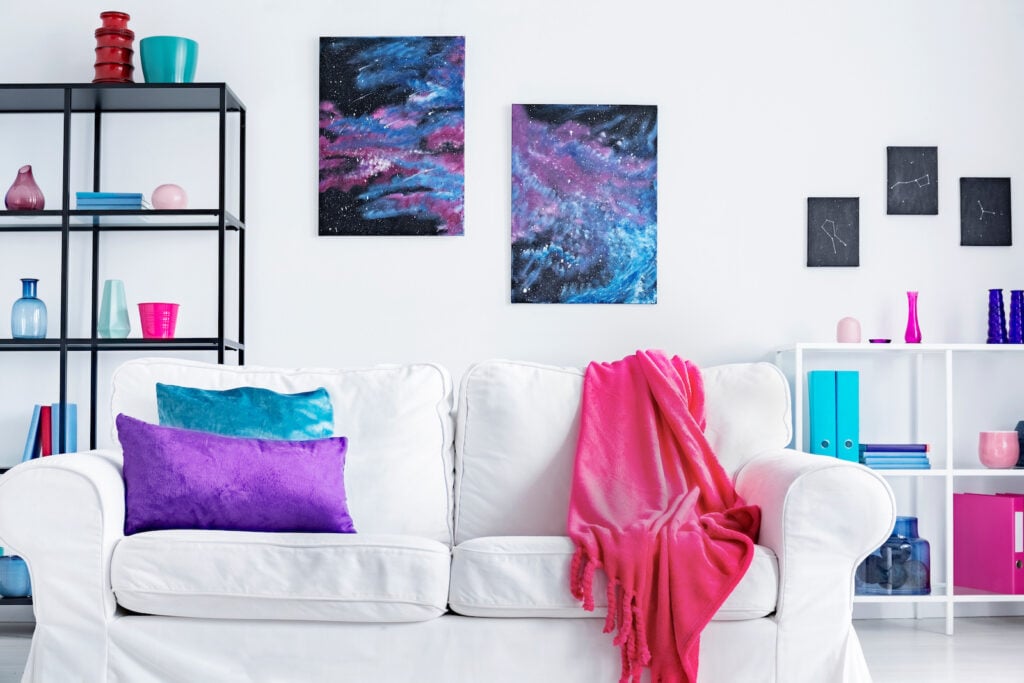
736, 449, 896, 681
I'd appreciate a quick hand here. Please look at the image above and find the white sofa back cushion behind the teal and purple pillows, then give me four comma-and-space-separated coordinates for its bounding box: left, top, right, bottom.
111, 358, 454, 544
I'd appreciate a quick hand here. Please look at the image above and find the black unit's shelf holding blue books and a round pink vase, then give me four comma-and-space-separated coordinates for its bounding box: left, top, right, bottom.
0, 209, 245, 232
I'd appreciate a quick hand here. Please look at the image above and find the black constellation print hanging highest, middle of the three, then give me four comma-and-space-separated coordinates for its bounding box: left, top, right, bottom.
886, 147, 939, 216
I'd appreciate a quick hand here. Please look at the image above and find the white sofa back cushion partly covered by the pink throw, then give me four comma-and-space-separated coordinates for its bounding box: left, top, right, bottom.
456, 360, 792, 544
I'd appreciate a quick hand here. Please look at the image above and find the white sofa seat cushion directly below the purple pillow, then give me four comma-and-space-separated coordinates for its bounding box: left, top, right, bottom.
111, 529, 451, 622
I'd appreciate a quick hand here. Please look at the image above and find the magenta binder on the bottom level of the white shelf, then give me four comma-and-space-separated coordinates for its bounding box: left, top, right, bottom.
953, 494, 1024, 595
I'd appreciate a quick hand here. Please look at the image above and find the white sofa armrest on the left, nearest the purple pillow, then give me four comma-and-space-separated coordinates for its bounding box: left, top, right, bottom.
0, 451, 125, 681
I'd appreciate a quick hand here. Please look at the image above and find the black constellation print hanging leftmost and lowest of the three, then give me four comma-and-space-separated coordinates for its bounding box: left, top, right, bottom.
807, 197, 860, 266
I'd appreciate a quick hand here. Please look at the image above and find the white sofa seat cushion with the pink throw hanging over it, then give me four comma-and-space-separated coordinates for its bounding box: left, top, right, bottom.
449, 536, 778, 622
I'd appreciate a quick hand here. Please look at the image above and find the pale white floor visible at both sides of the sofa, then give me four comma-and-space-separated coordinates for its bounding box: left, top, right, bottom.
0, 616, 1024, 683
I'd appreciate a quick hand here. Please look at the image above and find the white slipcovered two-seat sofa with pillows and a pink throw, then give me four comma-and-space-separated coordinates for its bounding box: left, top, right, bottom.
0, 358, 895, 683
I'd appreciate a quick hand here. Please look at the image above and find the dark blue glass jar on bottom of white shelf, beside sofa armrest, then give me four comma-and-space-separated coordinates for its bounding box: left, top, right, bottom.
854, 517, 932, 595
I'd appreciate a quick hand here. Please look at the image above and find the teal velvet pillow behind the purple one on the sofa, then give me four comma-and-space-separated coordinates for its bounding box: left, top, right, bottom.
157, 382, 334, 441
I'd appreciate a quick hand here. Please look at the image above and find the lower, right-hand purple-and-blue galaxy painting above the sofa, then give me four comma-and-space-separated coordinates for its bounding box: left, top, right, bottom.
512, 104, 657, 303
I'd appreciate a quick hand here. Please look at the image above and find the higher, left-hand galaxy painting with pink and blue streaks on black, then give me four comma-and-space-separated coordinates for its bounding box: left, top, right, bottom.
319, 36, 466, 236
